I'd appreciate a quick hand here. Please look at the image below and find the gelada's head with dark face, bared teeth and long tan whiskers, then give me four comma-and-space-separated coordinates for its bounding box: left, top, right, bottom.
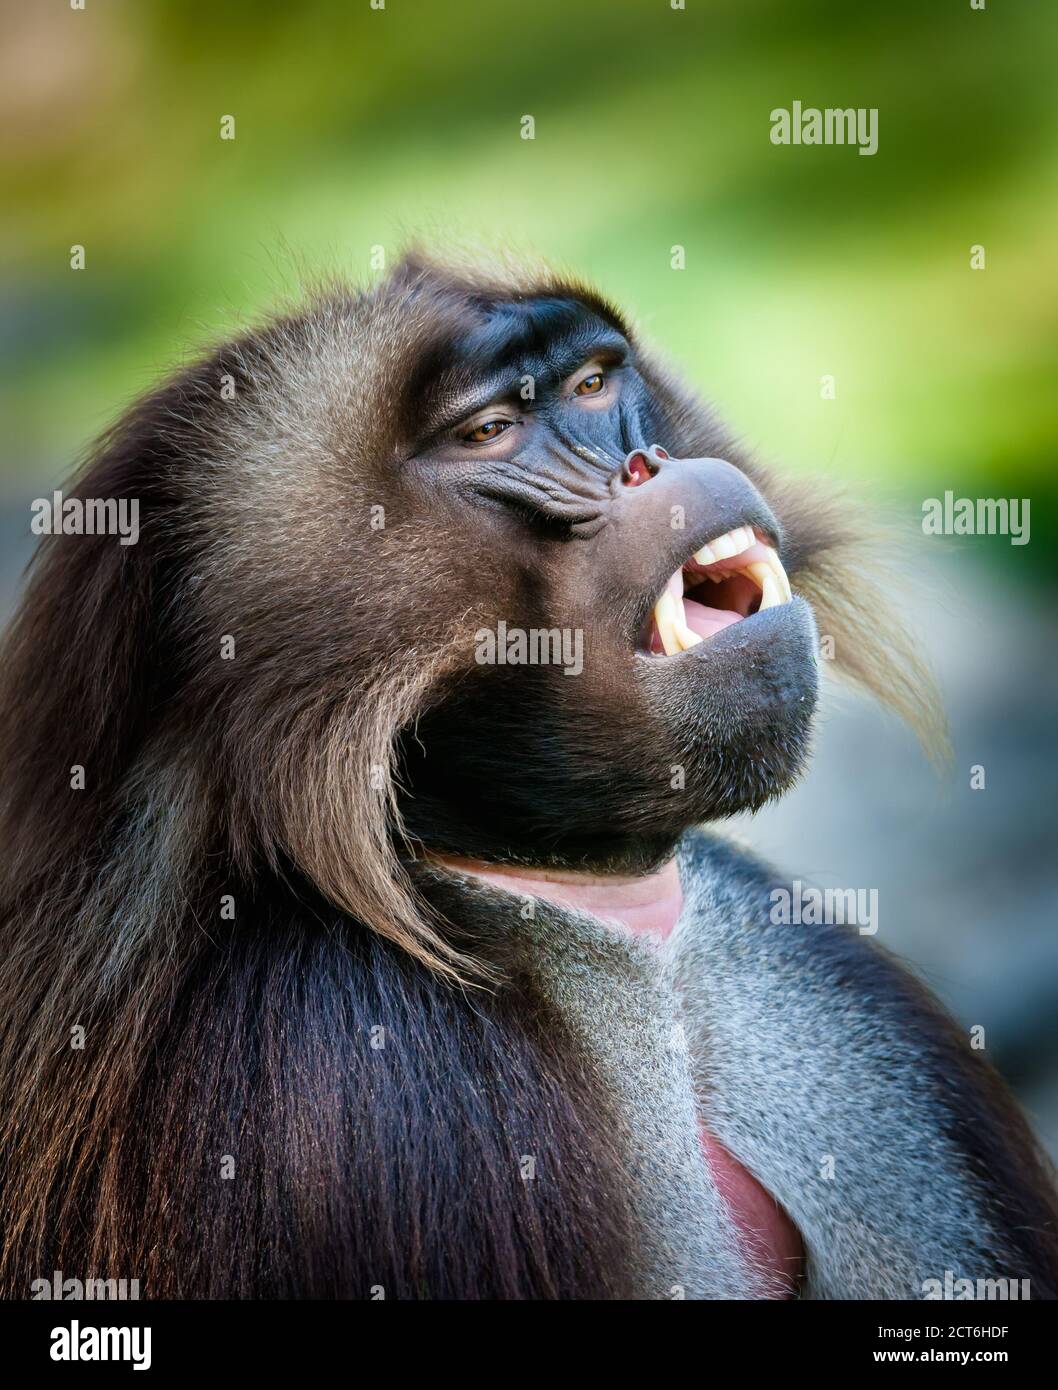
0, 257, 927, 960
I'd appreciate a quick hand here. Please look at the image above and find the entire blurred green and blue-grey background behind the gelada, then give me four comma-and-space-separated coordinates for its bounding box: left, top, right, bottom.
0, 0, 1058, 1139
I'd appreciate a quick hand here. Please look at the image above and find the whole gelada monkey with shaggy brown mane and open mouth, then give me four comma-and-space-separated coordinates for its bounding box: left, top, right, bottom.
0, 256, 1057, 1298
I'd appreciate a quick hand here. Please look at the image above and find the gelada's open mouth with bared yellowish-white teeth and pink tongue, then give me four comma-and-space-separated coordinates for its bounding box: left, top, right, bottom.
644, 525, 791, 656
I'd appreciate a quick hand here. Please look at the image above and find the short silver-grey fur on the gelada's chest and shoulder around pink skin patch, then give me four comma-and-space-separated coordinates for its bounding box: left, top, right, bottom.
427, 831, 1056, 1300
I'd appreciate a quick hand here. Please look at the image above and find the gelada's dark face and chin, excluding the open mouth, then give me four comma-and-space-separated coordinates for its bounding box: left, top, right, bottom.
402, 299, 816, 872
